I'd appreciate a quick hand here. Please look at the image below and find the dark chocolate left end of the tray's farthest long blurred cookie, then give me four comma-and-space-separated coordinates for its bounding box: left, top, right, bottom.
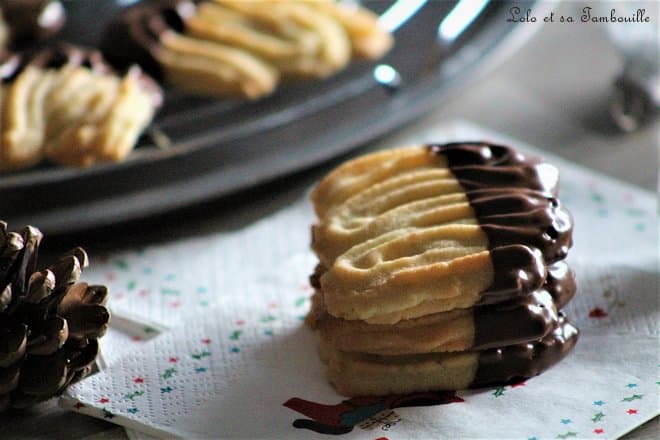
101, 0, 196, 80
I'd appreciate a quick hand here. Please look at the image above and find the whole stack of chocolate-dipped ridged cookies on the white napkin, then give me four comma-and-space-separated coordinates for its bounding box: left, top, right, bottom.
307, 142, 578, 396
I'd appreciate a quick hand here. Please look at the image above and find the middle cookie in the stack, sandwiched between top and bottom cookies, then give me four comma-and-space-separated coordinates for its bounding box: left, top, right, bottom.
306, 262, 575, 355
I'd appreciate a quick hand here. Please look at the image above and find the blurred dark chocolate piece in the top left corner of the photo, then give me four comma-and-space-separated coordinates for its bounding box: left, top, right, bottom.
0, 0, 66, 50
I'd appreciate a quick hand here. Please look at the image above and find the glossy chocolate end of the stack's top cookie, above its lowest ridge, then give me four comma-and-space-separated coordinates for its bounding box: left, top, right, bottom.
428, 142, 573, 264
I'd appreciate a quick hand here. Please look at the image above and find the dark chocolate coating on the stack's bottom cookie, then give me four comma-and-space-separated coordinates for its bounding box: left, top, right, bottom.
470, 315, 578, 388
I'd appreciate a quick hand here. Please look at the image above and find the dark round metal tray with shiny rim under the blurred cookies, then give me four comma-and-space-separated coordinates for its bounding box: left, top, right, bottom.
0, 0, 536, 233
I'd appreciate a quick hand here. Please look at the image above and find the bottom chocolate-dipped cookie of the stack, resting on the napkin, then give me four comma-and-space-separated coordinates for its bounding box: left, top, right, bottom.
319, 316, 578, 396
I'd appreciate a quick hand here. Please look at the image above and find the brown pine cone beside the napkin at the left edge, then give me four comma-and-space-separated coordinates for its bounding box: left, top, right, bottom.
0, 221, 110, 411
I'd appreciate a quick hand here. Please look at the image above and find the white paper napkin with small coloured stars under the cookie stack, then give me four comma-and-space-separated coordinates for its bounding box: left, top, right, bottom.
61, 122, 660, 439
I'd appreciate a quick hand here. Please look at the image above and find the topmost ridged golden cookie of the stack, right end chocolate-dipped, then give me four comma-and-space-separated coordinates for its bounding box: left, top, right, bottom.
312, 143, 572, 324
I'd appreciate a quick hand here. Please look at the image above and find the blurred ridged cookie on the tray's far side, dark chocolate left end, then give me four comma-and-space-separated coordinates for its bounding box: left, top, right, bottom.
102, 0, 392, 99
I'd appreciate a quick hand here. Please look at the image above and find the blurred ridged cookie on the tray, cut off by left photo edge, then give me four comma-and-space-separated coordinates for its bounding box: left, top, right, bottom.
0, 45, 162, 170
